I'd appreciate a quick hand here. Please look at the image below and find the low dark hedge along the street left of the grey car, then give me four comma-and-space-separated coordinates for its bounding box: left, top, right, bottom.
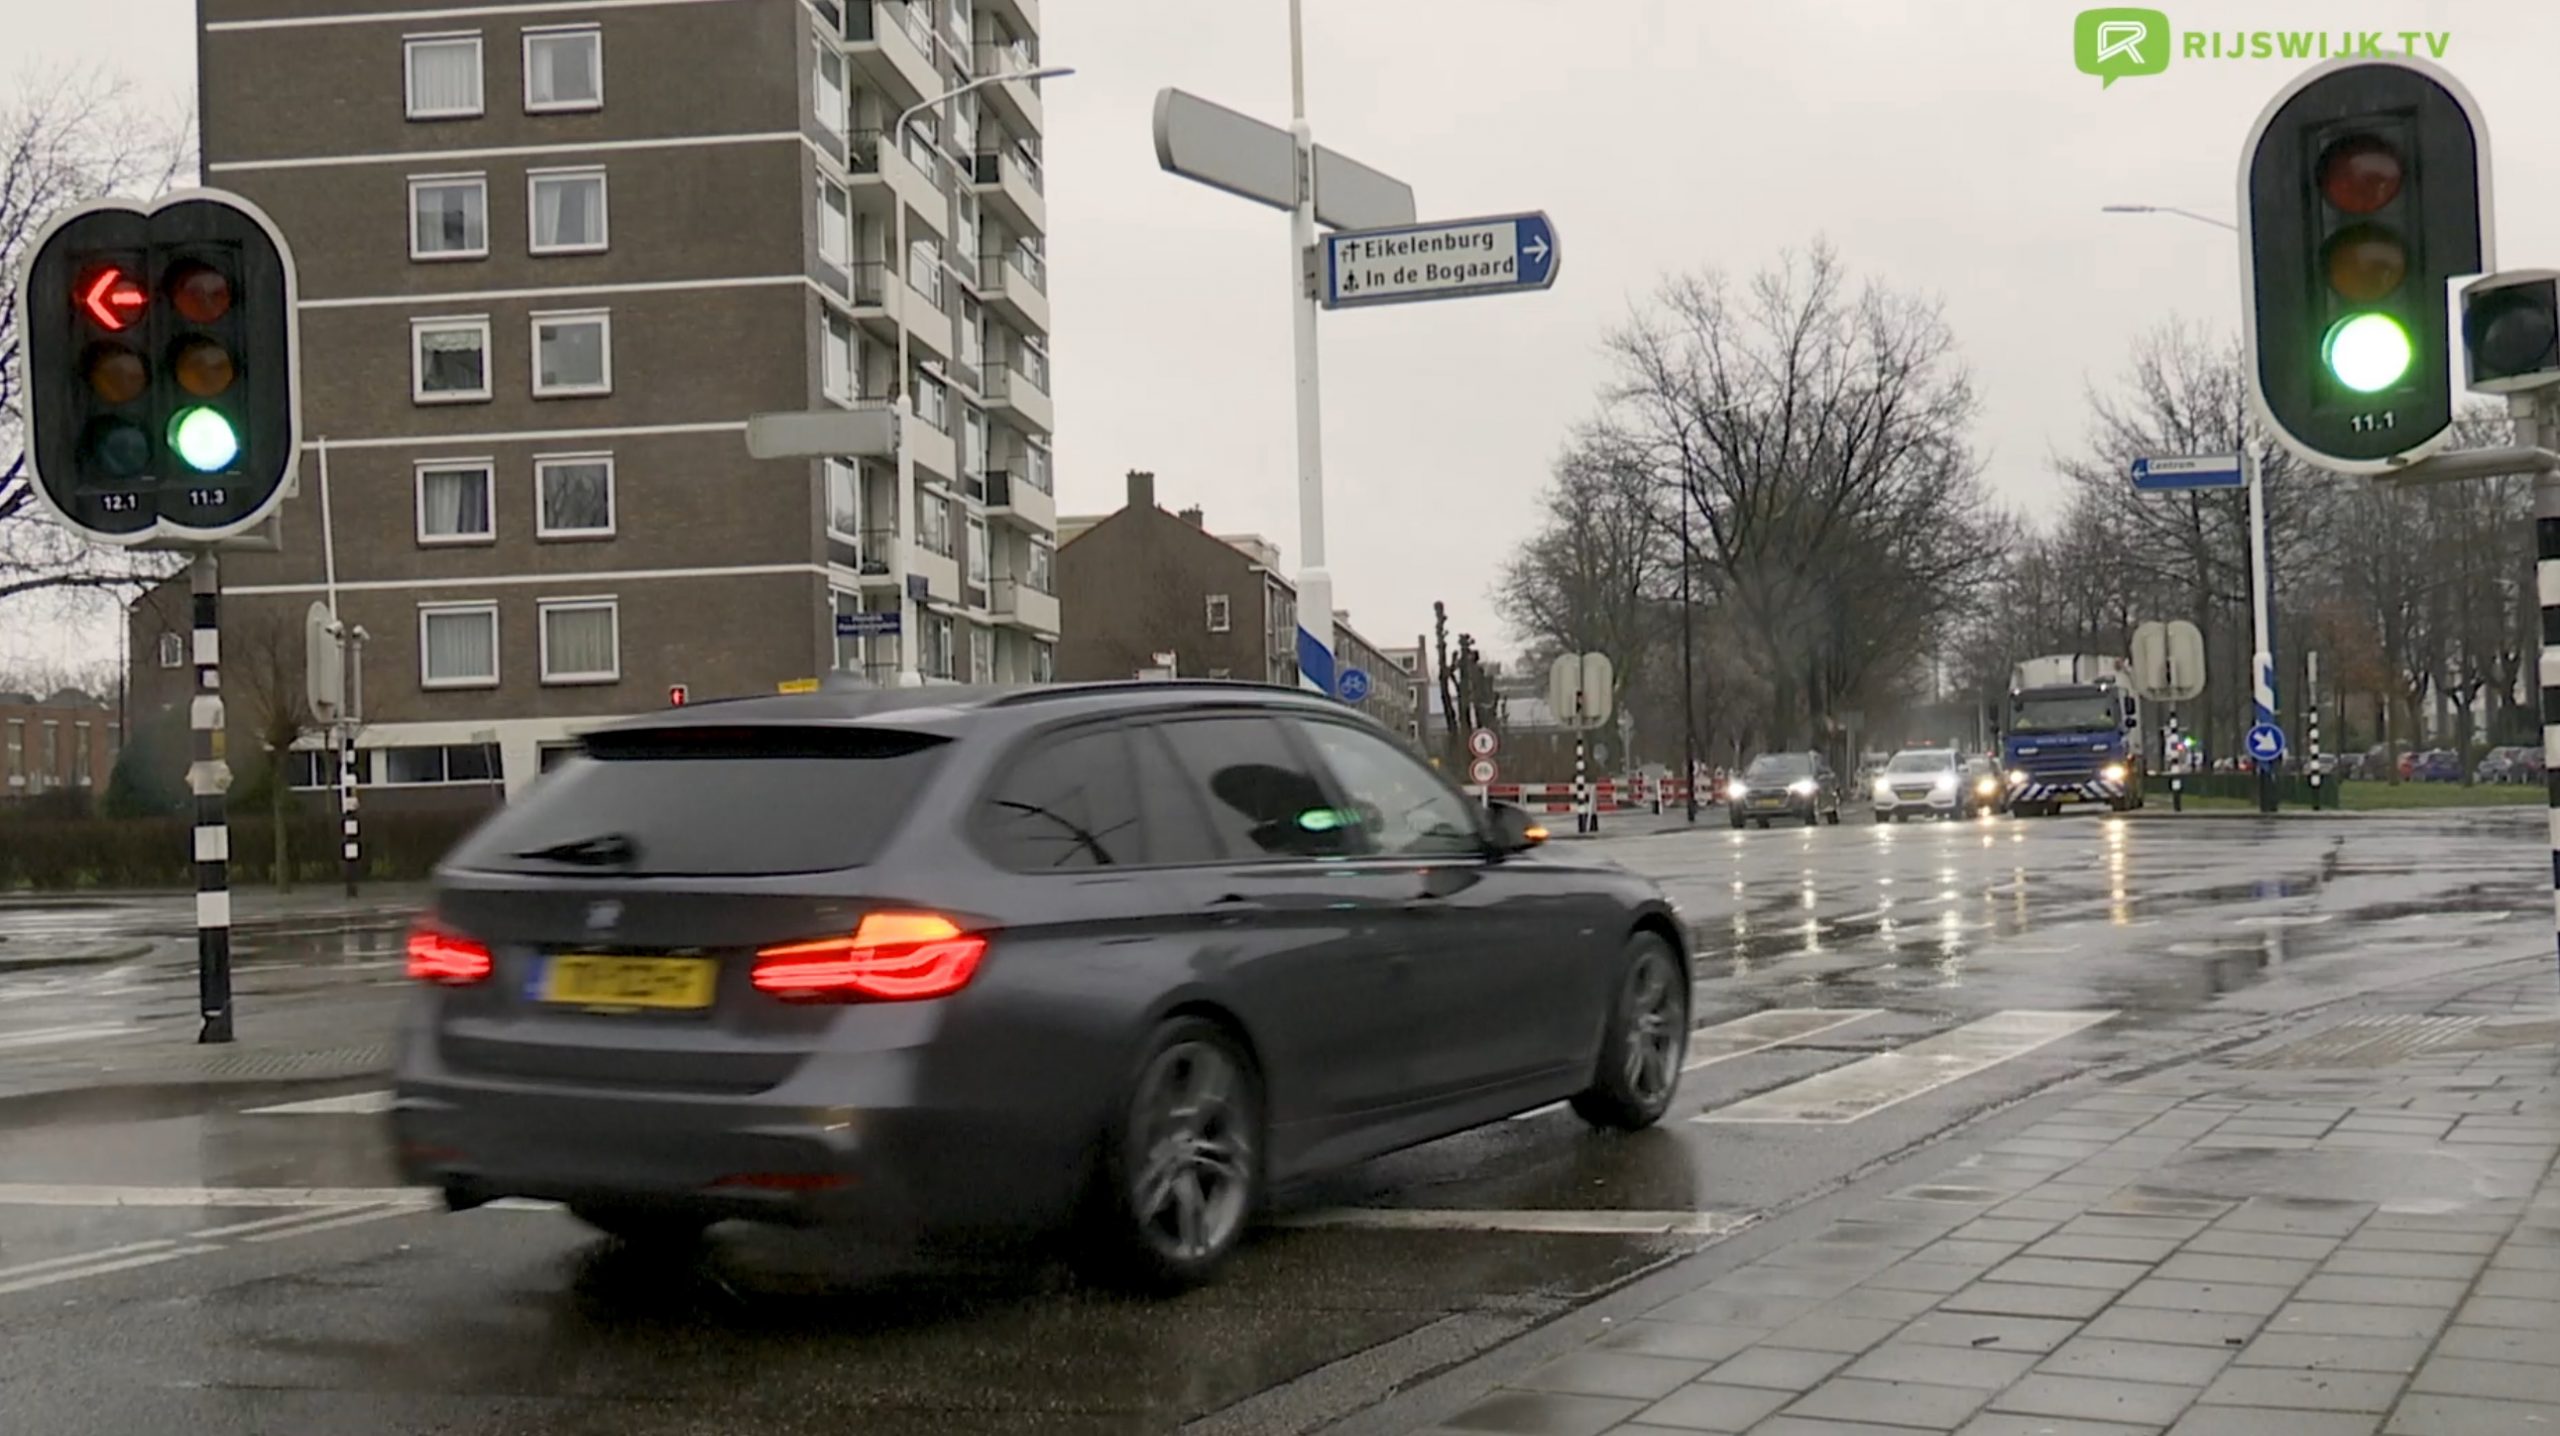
0, 809, 486, 893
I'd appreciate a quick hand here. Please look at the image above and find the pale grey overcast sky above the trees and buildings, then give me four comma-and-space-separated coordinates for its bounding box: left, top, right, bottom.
0, 0, 2560, 655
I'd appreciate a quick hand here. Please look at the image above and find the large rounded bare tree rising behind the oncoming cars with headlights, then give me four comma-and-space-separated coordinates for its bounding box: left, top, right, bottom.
1595, 243, 1992, 742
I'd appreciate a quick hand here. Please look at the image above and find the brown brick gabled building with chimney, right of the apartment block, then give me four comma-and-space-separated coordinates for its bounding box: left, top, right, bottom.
1057, 471, 1421, 737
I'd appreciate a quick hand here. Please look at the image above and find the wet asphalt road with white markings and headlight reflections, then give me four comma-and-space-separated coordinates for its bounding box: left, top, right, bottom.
0, 814, 2550, 1436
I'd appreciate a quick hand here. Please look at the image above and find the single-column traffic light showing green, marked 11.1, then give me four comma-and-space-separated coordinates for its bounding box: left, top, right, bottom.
2240, 56, 2491, 474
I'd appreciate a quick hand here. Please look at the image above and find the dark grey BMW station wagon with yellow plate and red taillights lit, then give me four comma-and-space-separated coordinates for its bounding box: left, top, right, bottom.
389, 681, 1690, 1288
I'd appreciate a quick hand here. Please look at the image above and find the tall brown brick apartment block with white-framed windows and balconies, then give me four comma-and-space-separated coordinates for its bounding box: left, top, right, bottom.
185, 0, 1057, 788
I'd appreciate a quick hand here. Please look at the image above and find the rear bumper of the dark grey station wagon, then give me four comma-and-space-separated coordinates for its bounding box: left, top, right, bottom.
389, 1013, 1088, 1244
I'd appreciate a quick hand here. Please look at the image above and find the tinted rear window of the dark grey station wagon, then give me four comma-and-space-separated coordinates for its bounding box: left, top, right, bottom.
451, 727, 947, 878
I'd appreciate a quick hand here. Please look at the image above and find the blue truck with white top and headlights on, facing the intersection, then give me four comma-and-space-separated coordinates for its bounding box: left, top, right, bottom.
1999, 653, 2143, 817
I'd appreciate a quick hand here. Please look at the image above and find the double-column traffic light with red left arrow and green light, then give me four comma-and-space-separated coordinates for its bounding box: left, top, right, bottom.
18, 189, 302, 548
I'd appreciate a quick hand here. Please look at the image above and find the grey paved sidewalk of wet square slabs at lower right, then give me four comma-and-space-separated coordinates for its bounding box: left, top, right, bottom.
1431, 973, 2560, 1436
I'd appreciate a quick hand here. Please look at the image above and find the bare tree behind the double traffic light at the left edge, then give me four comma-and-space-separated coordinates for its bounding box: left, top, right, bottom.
0, 72, 195, 616
